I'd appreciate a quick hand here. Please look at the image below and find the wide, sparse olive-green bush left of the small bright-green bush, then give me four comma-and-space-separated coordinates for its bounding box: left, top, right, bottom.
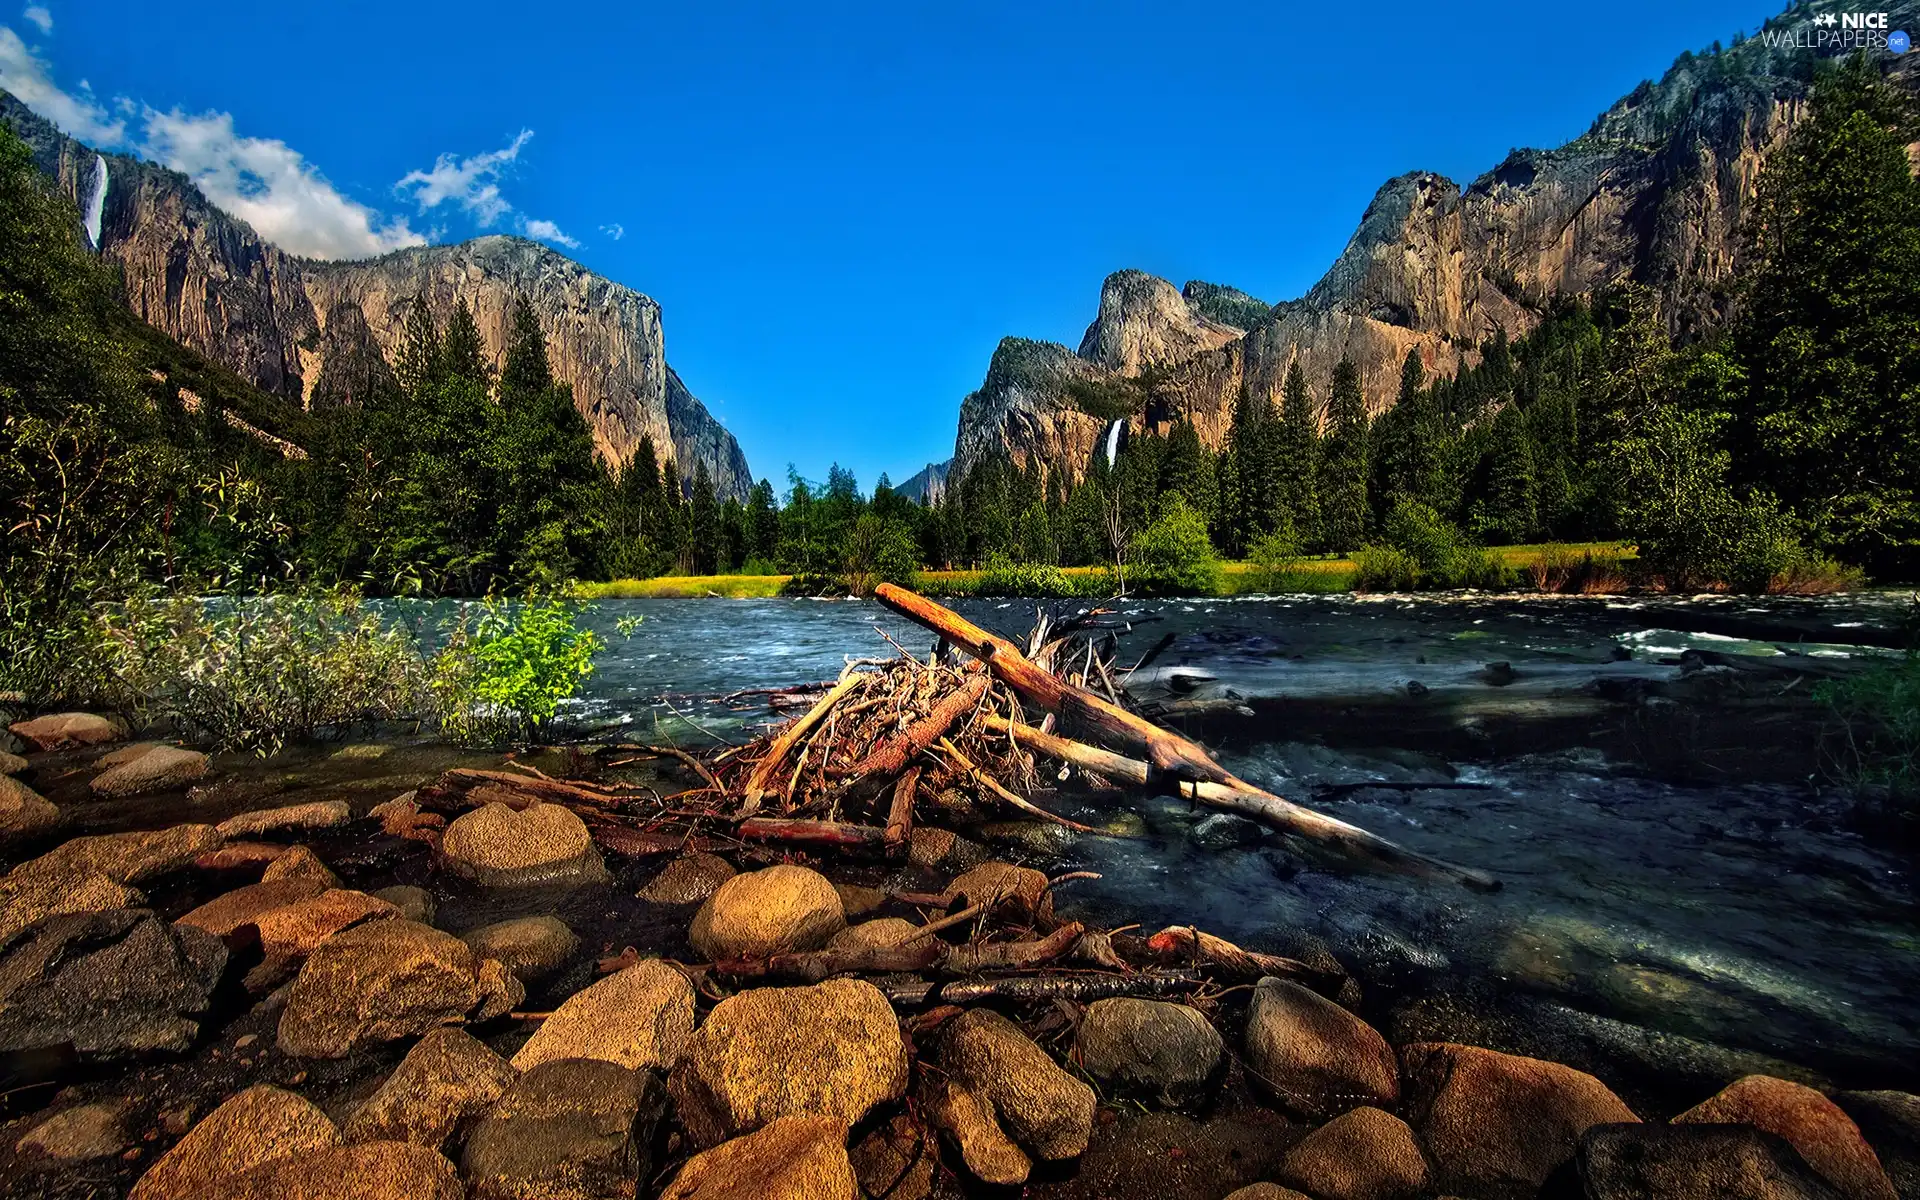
94, 588, 428, 755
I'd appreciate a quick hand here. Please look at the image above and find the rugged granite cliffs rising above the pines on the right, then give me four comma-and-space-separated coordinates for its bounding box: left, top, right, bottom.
954, 0, 1920, 476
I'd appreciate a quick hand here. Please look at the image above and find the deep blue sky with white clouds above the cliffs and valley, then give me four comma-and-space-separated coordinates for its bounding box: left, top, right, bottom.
0, 0, 1780, 486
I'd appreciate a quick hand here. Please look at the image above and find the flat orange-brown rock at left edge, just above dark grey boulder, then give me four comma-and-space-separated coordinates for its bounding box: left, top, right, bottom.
0, 826, 223, 945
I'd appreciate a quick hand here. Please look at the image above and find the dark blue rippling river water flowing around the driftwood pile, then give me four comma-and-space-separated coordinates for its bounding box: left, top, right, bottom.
560, 595, 1920, 1089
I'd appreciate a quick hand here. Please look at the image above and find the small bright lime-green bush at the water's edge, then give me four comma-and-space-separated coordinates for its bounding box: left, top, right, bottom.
432, 591, 605, 743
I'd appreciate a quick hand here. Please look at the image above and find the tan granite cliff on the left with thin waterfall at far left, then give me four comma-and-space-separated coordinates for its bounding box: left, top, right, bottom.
0, 92, 753, 499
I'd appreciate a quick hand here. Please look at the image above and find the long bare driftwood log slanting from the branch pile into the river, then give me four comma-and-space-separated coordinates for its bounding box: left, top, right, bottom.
874, 584, 1500, 891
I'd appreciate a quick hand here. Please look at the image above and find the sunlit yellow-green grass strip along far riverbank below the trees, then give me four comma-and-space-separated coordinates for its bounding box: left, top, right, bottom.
580, 541, 1634, 599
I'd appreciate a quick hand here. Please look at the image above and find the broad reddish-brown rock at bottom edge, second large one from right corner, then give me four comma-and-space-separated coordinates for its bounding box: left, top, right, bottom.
1400, 1043, 1640, 1200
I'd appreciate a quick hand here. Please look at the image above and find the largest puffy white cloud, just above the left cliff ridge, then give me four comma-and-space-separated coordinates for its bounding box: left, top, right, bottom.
142, 109, 426, 259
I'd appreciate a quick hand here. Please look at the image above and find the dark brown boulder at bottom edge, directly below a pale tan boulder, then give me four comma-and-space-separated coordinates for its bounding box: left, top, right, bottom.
461, 1058, 666, 1200
